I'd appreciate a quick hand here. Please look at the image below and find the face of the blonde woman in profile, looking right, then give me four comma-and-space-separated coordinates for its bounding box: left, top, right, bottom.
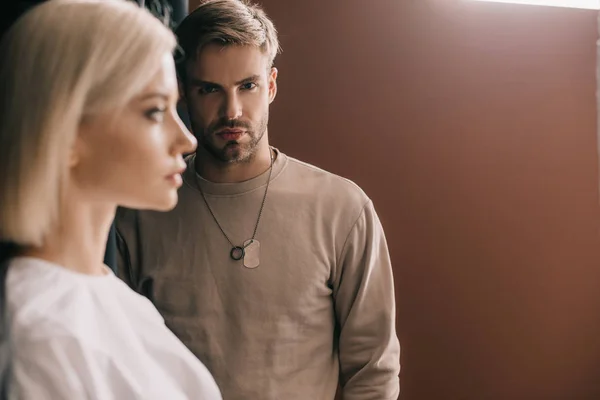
70, 53, 196, 211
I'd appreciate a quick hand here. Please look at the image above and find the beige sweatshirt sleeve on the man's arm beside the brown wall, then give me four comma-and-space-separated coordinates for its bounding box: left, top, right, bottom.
333, 201, 400, 400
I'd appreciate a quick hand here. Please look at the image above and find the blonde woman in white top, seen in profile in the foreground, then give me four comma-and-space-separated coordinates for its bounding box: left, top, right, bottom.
0, 0, 221, 400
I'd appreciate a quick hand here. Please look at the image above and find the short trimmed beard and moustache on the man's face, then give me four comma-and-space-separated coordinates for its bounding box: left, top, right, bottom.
192, 116, 268, 164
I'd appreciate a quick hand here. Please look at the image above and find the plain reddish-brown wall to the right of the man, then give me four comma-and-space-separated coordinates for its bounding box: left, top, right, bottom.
192, 0, 600, 400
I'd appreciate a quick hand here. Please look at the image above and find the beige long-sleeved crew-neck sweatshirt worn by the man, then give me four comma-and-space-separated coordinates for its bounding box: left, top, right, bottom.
116, 152, 400, 400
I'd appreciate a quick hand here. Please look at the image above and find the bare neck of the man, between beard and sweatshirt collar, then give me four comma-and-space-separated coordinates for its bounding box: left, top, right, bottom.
195, 144, 274, 183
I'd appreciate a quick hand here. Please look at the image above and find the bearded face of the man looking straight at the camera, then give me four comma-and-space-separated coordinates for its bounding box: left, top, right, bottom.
182, 44, 277, 163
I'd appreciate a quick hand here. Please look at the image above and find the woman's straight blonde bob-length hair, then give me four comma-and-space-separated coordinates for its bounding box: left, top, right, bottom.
0, 0, 176, 246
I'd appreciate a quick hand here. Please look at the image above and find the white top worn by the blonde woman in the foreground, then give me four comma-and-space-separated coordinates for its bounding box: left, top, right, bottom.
7, 257, 221, 400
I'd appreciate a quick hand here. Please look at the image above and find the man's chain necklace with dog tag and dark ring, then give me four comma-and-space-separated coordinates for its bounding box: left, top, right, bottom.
198, 149, 273, 269
